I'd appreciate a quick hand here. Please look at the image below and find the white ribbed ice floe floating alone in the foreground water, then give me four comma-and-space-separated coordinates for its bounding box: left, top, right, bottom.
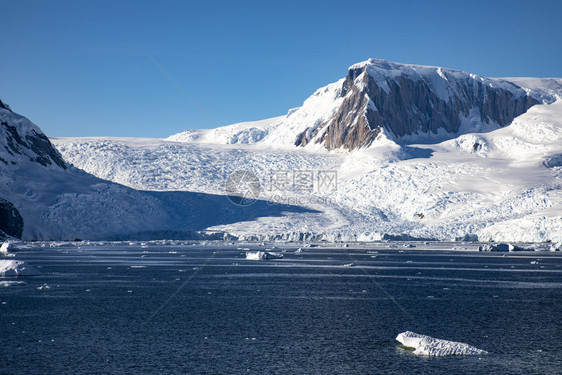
396, 331, 487, 356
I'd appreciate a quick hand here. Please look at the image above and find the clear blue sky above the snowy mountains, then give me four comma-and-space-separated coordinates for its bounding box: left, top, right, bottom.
0, 0, 562, 137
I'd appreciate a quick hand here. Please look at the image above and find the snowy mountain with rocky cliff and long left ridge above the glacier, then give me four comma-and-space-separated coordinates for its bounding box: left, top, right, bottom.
168, 59, 562, 150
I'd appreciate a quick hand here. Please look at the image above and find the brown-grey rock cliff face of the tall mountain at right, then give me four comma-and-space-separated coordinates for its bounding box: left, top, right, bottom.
295, 59, 539, 150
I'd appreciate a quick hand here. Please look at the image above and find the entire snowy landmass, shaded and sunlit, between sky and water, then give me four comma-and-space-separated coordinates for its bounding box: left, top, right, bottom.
4, 60, 562, 241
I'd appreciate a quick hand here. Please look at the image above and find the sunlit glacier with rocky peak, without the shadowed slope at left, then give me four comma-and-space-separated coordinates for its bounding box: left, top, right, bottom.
53, 60, 562, 241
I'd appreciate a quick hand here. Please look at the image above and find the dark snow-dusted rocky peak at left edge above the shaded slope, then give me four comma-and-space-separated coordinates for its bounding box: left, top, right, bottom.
0, 101, 66, 169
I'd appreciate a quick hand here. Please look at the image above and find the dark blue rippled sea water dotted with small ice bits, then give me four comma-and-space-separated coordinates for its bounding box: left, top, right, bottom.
0, 244, 562, 375
